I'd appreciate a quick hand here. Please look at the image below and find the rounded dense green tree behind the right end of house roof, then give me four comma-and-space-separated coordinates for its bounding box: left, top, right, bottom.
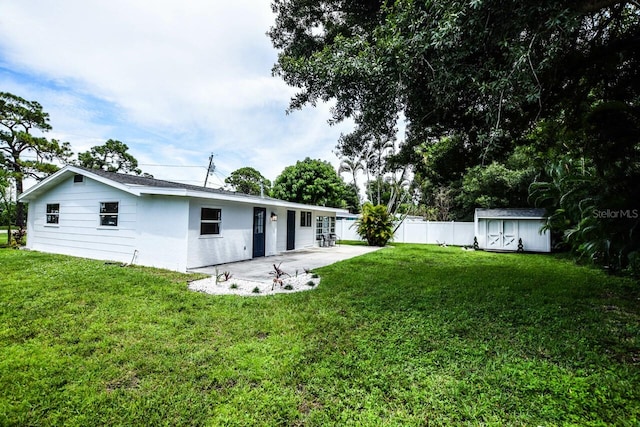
272, 157, 347, 208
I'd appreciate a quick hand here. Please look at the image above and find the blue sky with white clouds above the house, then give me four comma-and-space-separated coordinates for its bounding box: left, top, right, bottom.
0, 0, 352, 186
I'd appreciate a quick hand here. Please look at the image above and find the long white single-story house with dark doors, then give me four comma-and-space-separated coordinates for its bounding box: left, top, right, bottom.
20, 166, 346, 272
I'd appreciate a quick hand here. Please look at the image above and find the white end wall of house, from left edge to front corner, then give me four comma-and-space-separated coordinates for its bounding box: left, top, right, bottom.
27, 177, 195, 271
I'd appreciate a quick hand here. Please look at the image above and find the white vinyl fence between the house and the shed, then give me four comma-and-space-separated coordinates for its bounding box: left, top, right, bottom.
336, 218, 474, 246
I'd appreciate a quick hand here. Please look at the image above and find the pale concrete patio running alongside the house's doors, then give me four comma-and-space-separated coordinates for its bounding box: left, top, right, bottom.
189, 245, 380, 281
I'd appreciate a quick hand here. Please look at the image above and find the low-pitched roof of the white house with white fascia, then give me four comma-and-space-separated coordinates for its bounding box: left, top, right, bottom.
19, 165, 348, 214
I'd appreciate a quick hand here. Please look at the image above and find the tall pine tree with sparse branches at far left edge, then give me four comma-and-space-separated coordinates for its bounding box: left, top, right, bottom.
0, 92, 72, 227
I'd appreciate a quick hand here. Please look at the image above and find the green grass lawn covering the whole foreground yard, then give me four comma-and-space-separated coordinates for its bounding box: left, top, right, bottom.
0, 245, 640, 426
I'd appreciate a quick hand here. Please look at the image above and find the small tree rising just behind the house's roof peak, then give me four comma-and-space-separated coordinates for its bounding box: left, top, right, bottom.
78, 139, 142, 175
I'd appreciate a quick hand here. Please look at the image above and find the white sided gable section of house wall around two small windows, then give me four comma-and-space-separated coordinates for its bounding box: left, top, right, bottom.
27, 177, 138, 262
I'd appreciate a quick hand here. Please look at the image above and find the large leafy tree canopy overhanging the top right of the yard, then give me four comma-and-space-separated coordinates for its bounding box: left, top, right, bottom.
270, 0, 640, 159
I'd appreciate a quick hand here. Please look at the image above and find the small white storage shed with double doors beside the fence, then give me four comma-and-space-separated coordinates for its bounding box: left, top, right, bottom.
474, 208, 551, 252
